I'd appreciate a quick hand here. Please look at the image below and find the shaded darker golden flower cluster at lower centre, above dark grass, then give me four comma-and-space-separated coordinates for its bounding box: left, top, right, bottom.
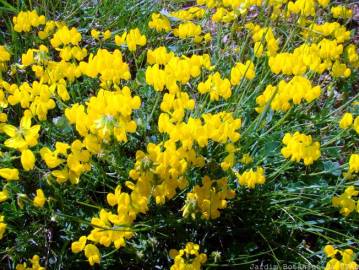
182, 176, 236, 220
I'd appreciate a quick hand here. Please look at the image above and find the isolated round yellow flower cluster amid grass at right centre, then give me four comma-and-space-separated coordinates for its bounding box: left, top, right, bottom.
281, 131, 320, 166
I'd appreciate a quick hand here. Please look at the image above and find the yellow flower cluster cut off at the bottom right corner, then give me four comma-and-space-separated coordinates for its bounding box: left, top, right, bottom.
324, 245, 358, 270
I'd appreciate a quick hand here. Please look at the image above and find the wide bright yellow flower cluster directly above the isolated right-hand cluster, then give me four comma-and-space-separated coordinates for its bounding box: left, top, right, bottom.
256, 76, 321, 113
